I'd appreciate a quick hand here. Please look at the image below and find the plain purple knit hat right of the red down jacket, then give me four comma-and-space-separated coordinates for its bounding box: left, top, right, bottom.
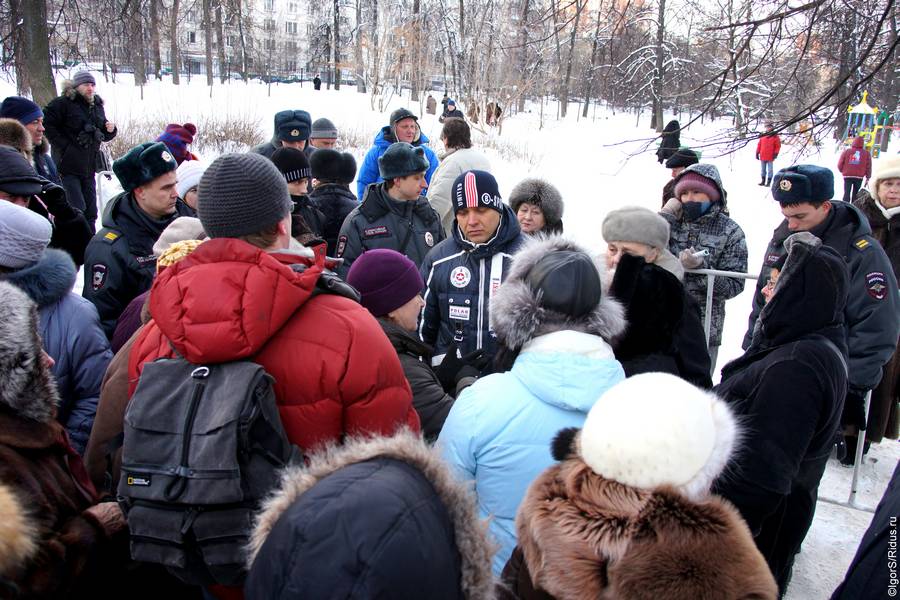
347, 248, 425, 317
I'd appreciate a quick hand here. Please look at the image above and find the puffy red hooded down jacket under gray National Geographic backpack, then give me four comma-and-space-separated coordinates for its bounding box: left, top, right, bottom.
128, 238, 419, 453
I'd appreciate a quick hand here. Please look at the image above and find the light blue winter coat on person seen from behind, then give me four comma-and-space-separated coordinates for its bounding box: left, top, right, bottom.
437, 330, 625, 576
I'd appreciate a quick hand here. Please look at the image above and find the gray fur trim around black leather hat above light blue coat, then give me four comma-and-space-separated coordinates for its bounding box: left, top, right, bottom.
490, 236, 626, 350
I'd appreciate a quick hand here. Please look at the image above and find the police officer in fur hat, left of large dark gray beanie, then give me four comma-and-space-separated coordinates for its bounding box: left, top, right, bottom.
82, 142, 187, 337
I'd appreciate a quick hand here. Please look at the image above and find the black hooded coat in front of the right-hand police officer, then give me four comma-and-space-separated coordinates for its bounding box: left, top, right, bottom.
715, 234, 849, 586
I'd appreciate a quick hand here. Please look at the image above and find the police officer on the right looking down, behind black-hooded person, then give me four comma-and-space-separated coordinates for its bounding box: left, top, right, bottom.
743, 165, 900, 452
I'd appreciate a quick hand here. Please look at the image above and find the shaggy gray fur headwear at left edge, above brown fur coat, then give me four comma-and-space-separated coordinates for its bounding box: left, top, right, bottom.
0, 281, 59, 423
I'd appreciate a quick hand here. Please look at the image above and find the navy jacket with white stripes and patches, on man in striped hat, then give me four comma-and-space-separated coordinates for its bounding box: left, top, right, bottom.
419, 204, 525, 365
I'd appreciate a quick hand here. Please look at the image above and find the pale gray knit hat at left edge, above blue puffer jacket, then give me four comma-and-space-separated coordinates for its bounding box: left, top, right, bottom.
0, 200, 53, 269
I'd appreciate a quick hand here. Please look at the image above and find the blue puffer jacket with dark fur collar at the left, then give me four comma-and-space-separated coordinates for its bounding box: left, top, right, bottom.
3, 248, 112, 454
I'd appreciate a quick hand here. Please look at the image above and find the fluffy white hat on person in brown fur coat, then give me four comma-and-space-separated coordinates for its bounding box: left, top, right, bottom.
580, 373, 738, 499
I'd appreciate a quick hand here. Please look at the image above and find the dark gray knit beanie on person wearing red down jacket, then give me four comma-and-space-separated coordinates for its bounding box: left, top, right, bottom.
197, 154, 291, 238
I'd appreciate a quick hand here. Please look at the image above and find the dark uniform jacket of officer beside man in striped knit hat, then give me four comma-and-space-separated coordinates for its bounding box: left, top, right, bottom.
336, 183, 445, 277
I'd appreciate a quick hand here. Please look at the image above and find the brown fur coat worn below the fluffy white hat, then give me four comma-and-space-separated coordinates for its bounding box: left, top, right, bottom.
504, 438, 777, 600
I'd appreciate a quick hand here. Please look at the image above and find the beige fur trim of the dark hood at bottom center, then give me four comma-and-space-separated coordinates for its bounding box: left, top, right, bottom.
248, 430, 494, 598
